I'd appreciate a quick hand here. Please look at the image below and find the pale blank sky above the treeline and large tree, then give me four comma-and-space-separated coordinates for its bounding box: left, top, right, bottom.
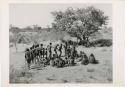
9, 3, 112, 28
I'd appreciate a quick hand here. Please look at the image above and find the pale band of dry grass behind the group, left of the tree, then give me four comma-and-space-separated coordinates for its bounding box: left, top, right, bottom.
9, 31, 69, 44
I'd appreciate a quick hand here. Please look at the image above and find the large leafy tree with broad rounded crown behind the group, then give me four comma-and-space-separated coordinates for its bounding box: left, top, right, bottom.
52, 7, 108, 44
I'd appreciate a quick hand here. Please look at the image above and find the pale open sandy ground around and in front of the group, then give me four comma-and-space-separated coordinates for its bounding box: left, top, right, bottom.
10, 44, 112, 83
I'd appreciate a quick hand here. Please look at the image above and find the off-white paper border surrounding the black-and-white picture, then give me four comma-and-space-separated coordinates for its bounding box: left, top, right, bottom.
0, 0, 125, 87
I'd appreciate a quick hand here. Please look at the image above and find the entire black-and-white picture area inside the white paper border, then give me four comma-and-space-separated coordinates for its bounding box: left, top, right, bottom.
9, 3, 113, 84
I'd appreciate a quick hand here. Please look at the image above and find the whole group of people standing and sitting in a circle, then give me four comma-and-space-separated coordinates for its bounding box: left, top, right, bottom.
25, 42, 97, 69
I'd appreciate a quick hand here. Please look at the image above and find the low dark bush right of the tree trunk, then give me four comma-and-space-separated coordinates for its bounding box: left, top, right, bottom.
90, 39, 112, 47
